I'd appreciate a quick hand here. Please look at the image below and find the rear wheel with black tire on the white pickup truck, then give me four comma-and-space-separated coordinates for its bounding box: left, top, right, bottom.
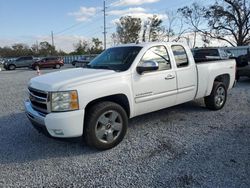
204, 82, 227, 110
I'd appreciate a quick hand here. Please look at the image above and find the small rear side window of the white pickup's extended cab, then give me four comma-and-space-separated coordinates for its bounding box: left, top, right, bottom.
172, 45, 188, 68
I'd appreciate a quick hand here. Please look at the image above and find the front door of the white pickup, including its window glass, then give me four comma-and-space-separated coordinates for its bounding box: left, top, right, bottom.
132, 45, 177, 115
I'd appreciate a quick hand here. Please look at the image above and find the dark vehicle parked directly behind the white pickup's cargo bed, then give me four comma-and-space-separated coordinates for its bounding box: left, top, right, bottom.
193, 48, 230, 62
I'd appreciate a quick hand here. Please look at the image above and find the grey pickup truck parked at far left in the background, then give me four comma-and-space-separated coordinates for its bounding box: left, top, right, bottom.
4, 56, 37, 70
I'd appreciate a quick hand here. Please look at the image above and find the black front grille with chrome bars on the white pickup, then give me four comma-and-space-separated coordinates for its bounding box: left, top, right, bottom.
28, 88, 49, 114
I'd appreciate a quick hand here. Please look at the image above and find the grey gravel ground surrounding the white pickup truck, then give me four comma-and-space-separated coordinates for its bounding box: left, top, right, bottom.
0, 69, 250, 188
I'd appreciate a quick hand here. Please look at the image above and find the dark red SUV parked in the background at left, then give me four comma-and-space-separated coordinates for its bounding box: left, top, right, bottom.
31, 57, 64, 69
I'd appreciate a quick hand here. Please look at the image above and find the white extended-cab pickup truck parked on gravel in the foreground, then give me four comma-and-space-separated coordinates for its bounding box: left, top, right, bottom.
25, 43, 236, 149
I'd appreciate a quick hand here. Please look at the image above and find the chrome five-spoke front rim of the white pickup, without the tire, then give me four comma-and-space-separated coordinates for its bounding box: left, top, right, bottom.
95, 110, 123, 144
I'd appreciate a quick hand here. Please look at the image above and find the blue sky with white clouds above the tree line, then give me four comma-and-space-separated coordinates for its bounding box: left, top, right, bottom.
0, 0, 211, 52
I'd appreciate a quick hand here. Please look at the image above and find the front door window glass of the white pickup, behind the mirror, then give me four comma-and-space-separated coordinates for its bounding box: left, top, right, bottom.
141, 46, 171, 71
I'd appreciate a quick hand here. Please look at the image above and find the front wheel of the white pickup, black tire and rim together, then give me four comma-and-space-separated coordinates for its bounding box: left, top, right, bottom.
83, 101, 128, 150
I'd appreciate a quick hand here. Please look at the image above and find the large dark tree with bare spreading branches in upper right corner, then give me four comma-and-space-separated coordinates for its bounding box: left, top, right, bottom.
205, 0, 250, 46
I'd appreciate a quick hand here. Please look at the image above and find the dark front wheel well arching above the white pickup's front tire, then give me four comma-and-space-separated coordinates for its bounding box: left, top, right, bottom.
85, 94, 130, 117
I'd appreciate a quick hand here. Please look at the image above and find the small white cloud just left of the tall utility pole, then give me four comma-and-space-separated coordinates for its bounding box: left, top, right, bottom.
68, 7, 98, 22
